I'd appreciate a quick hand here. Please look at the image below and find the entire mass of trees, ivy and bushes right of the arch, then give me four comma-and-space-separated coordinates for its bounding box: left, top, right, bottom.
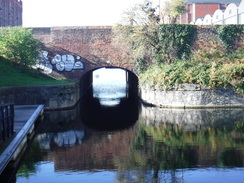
113, 0, 244, 93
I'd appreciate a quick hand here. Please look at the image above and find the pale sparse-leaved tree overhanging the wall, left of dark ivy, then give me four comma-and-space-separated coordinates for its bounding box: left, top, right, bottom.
113, 0, 160, 71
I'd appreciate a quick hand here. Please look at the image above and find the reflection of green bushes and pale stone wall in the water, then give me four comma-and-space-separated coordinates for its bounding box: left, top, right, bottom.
113, 108, 244, 182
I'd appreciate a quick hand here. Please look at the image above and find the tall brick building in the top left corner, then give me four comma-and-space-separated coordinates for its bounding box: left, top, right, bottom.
0, 0, 23, 27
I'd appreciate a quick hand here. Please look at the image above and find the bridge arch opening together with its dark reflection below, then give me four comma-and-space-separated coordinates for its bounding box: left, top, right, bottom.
78, 67, 140, 130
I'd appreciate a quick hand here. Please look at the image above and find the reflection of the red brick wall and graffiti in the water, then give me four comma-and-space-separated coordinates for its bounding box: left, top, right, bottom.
18, 107, 135, 176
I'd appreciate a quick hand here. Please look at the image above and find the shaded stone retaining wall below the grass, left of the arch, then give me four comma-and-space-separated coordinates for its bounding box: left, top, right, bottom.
0, 83, 80, 110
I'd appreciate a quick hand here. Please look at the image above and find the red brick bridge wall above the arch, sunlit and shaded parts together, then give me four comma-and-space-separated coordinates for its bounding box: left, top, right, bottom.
33, 26, 135, 78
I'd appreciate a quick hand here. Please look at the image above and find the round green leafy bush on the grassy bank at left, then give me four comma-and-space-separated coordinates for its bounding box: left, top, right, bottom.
0, 27, 40, 65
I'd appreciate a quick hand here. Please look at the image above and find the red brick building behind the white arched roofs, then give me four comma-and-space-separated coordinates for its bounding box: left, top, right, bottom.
180, 0, 241, 24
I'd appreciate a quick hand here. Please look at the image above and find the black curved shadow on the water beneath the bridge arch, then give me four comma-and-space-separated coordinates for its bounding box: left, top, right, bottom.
81, 87, 139, 131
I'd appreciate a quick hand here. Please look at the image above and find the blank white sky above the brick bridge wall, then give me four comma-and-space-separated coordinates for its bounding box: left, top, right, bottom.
22, 0, 163, 27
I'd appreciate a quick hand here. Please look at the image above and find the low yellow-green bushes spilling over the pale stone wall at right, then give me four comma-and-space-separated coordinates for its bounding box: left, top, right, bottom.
140, 45, 244, 93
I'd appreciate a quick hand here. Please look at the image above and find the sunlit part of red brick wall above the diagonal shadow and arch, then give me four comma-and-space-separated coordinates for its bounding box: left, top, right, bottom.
51, 26, 131, 69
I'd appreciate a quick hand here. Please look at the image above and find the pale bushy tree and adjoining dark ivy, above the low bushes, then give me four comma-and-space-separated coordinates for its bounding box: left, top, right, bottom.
113, 0, 187, 72
